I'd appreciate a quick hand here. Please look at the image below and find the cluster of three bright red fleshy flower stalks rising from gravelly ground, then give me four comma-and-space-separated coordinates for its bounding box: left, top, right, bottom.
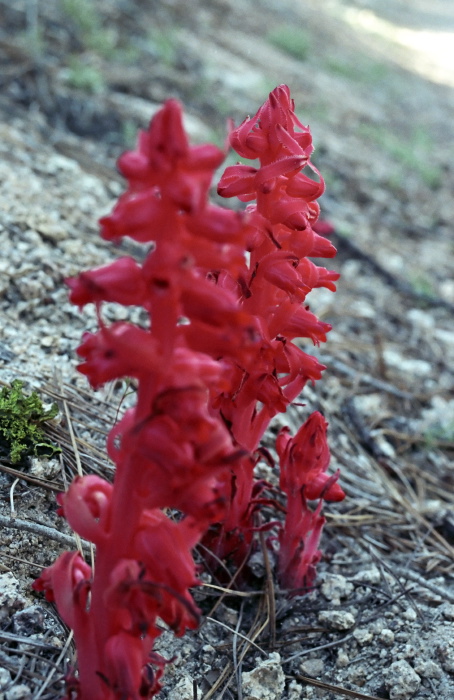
34, 86, 343, 700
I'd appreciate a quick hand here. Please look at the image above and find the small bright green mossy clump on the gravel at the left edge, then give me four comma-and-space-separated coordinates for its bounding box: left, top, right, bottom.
0, 379, 60, 463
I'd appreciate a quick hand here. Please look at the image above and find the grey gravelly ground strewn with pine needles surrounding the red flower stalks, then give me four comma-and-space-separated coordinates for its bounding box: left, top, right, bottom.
0, 0, 454, 700
